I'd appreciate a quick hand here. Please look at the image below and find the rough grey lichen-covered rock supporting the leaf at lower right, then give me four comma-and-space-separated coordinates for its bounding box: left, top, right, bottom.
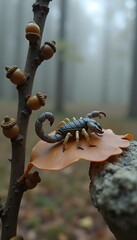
89, 141, 137, 240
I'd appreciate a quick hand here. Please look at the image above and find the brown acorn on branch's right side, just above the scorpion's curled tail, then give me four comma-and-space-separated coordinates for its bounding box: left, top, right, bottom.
27, 92, 47, 110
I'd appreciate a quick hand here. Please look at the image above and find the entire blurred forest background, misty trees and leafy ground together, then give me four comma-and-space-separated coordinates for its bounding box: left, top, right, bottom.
0, 0, 137, 240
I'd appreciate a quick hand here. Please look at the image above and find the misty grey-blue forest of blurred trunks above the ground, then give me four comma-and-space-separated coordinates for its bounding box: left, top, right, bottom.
0, 0, 137, 116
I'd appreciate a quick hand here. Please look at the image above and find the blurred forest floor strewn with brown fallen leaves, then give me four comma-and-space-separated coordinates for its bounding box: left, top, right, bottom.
0, 102, 137, 240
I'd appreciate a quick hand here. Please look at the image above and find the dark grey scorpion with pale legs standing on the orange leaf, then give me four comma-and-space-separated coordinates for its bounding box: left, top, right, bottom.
35, 111, 106, 152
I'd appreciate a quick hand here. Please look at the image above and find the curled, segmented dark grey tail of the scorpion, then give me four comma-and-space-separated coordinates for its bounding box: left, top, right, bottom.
35, 112, 62, 143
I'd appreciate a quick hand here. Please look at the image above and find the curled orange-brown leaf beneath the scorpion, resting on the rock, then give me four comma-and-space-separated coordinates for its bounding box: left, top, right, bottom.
28, 129, 132, 170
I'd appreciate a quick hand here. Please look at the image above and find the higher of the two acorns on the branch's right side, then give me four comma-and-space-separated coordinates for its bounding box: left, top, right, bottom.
40, 41, 56, 60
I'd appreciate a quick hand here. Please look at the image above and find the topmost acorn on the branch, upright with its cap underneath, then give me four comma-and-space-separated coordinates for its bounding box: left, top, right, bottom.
25, 22, 40, 43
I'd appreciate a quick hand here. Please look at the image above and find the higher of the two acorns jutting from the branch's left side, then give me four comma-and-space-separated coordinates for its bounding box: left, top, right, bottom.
5, 65, 26, 85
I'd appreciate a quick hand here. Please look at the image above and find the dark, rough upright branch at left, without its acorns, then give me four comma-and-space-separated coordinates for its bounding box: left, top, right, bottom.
1, 0, 50, 240
